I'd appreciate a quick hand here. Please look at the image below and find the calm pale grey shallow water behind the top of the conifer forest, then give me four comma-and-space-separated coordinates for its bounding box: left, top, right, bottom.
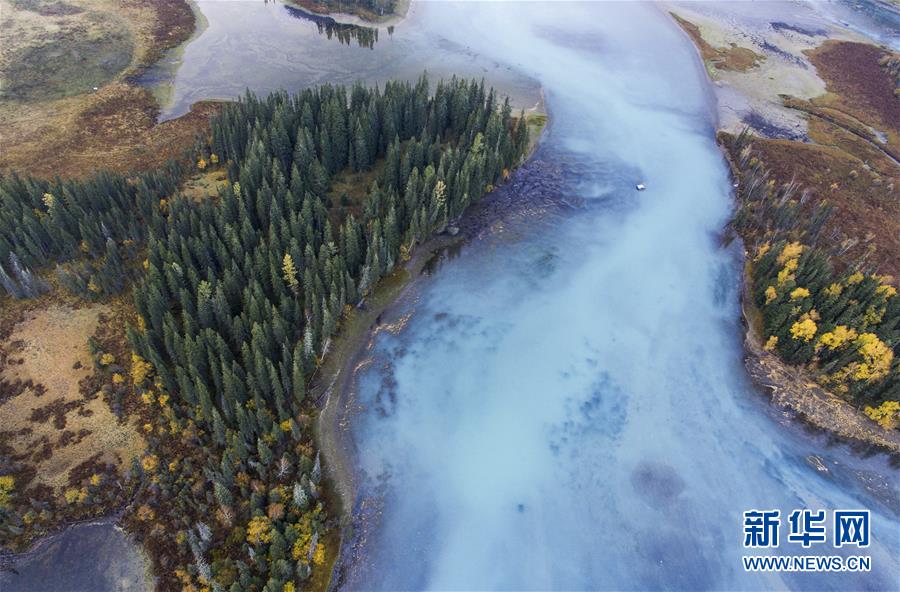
149, 0, 537, 119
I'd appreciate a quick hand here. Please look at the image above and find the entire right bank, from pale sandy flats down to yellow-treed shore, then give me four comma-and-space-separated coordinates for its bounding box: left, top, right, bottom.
673, 6, 900, 453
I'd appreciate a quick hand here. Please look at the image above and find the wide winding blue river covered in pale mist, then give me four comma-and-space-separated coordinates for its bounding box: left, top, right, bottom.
345, 3, 900, 590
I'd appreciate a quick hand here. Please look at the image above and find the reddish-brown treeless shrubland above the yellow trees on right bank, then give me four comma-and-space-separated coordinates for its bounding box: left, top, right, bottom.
744, 41, 900, 277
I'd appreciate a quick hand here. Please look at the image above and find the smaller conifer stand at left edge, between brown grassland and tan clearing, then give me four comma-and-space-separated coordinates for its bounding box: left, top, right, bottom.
0, 164, 183, 298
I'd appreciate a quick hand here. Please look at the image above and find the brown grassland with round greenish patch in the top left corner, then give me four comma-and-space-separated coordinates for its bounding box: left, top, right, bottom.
0, 0, 218, 177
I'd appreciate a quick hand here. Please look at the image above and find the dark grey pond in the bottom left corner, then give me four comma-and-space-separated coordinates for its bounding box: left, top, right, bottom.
0, 520, 153, 592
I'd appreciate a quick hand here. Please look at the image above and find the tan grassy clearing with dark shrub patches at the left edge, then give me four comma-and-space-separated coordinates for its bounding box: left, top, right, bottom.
0, 290, 151, 550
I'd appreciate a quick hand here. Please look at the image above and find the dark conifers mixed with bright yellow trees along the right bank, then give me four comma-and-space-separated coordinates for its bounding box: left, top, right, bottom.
734, 131, 900, 414
